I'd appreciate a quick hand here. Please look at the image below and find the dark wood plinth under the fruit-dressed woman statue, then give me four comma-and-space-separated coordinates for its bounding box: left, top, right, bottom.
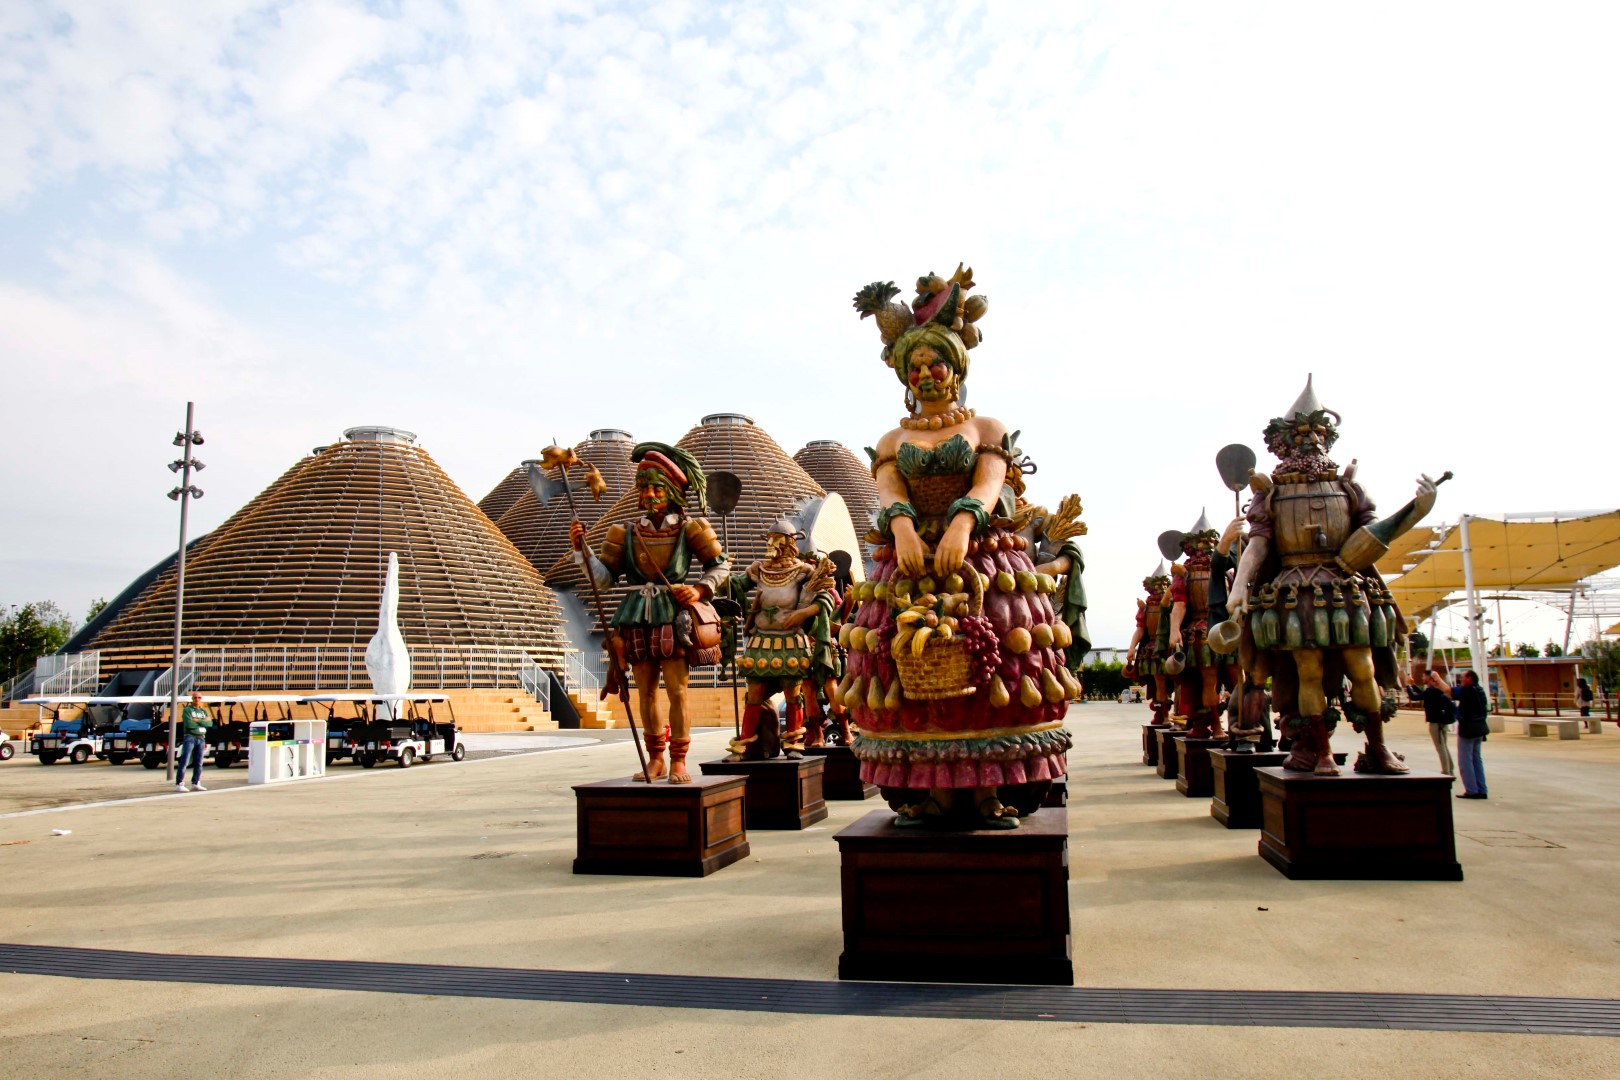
834, 810, 1074, 986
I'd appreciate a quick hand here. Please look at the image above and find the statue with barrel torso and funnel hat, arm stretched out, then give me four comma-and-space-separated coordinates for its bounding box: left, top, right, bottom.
1228, 381, 1450, 776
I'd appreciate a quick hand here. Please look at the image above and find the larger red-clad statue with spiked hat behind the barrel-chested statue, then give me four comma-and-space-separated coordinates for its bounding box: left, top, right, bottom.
1168, 513, 1238, 738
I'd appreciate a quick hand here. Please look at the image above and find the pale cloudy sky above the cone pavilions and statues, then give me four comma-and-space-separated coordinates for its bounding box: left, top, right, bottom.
0, 0, 1620, 644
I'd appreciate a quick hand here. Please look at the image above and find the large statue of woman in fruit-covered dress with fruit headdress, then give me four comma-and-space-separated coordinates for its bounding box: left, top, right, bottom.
839, 267, 1085, 829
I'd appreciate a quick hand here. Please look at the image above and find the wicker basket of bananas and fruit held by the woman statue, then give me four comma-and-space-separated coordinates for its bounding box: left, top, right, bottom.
889, 565, 987, 701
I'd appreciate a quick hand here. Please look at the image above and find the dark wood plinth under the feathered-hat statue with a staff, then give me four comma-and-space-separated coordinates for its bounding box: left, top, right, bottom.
573, 776, 748, 878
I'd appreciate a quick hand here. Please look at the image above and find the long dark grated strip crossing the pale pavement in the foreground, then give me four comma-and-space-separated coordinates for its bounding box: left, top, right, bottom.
0, 944, 1620, 1036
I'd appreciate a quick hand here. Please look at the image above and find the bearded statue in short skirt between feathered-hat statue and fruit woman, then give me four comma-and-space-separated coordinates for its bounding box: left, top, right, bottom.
726, 518, 838, 761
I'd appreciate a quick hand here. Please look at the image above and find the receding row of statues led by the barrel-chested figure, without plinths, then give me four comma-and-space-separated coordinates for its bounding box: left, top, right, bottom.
1129, 381, 1450, 776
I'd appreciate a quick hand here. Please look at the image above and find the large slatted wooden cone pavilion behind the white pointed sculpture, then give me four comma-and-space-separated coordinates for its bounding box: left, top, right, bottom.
89, 427, 565, 690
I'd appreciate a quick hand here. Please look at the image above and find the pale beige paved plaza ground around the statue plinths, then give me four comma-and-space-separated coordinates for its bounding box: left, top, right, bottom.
0, 704, 1620, 1080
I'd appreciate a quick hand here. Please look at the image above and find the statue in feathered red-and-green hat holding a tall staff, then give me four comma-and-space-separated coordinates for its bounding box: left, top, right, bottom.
569, 442, 731, 784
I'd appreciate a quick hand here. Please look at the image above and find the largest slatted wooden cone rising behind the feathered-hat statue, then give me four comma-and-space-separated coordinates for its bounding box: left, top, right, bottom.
546, 413, 826, 615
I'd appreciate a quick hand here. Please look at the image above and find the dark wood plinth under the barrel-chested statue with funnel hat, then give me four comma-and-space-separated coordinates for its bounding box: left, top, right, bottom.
1254, 766, 1463, 881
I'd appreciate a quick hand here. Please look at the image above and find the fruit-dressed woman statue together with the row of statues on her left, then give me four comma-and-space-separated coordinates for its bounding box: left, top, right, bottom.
570, 266, 1090, 829
